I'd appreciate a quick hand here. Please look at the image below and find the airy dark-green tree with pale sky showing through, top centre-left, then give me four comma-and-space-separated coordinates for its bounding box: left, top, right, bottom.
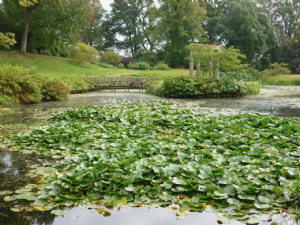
104, 0, 156, 56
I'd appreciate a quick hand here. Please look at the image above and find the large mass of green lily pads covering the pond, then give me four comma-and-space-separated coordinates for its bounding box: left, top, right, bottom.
0, 101, 300, 224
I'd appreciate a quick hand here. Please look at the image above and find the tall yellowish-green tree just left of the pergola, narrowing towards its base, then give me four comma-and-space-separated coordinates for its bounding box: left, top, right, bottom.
157, 0, 206, 67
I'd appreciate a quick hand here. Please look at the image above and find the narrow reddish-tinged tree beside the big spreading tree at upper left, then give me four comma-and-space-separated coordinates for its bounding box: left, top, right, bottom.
80, 0, 105, 50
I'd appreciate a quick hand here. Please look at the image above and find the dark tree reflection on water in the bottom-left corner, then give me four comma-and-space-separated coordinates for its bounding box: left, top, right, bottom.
0, 199, 55, 225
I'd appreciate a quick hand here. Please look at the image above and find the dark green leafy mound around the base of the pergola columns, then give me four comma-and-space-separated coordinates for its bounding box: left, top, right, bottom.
158, 77, 245, 98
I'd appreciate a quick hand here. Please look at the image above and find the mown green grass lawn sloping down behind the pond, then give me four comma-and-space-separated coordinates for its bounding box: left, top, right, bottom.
0, 51, 189, 78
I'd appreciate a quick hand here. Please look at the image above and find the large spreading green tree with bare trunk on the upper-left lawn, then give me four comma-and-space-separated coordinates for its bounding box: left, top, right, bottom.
19, 0, 92, 53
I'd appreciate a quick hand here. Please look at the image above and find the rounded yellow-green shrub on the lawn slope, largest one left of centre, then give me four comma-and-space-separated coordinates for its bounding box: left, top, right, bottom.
68, 43, 99, 65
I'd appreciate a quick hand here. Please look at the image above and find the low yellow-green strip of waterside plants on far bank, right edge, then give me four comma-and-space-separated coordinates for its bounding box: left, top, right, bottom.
260, 75, 300, 86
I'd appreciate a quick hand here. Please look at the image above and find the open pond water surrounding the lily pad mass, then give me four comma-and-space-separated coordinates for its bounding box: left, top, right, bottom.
0, 86, 300, 225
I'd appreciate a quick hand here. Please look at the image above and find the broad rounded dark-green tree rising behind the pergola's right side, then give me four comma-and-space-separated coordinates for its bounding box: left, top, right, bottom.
208, 1, 272, 63
